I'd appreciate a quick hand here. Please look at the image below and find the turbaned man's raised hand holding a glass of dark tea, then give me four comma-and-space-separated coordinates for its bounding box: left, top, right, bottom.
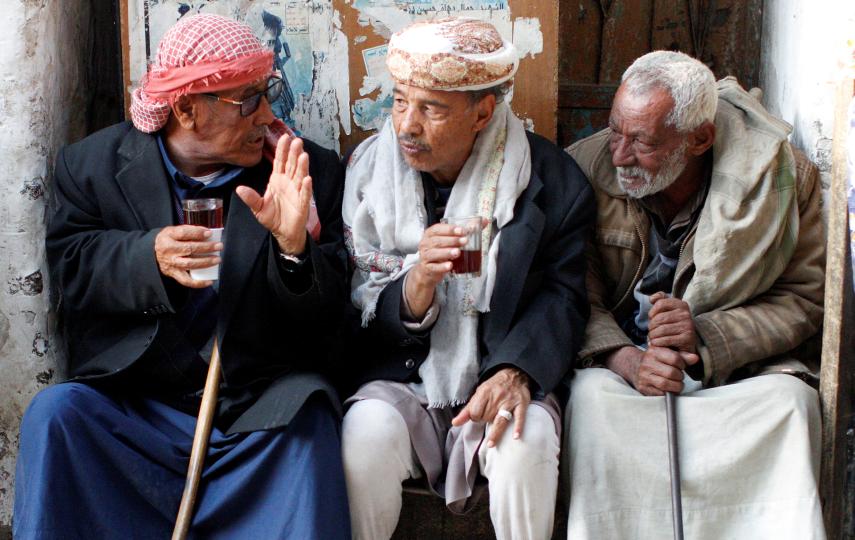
404, 223, 466, 319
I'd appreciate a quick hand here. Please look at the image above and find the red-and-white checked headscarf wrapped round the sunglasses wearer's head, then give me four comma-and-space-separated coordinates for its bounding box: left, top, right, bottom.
131, 14, 273, 133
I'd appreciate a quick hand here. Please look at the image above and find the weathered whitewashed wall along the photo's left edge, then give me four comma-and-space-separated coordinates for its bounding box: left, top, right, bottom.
0, 0, 90, 539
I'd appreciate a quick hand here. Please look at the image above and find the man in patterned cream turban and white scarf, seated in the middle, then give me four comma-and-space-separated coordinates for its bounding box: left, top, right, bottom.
342, 19, 593, 540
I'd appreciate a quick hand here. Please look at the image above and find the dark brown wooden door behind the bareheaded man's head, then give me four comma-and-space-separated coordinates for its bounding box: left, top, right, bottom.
558, 0, 763, 146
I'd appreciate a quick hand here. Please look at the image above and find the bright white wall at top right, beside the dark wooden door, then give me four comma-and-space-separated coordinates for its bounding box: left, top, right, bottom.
760, 0, 855, 193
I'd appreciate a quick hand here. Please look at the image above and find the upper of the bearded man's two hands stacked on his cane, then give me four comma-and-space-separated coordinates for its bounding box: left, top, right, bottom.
647, 292, 698, 353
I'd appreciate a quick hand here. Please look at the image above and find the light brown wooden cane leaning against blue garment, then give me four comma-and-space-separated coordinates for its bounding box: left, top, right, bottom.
172, 338, 220, 540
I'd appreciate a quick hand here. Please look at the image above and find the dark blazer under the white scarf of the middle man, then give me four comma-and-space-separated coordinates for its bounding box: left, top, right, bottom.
350, 133, 596, 393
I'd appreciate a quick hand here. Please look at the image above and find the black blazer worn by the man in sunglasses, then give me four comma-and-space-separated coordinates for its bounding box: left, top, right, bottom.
47, 122, 347, 432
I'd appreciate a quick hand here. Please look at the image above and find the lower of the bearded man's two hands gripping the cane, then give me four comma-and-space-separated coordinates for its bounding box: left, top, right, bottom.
606, 346, 699, 396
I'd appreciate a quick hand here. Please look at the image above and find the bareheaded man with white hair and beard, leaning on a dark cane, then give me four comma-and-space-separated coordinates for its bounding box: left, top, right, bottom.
565, 51, 825, 540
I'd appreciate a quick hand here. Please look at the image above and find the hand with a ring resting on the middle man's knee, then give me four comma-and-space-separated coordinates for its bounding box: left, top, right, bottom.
451, 367, 531, 448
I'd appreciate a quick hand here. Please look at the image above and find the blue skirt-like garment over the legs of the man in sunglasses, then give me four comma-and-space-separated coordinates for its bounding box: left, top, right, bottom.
13, 383, 350, 540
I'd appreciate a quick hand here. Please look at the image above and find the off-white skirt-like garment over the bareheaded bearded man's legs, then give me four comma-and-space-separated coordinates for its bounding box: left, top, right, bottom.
564, 368, 825, 540
